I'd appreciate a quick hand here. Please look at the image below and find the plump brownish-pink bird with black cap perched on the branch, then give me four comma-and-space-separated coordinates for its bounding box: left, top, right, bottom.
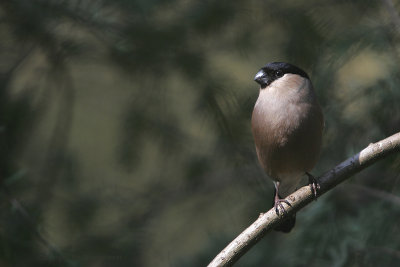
251, 62, 324, 233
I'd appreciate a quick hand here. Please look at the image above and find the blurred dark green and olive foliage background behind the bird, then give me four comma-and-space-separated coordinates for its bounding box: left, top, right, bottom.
0, 0, 400, 267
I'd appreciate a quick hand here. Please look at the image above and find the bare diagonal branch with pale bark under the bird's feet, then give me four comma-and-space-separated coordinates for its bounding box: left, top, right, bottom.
208, 133, 400, 267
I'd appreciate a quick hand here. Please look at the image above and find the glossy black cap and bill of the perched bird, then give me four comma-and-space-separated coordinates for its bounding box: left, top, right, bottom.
254, 62, 309, 88
